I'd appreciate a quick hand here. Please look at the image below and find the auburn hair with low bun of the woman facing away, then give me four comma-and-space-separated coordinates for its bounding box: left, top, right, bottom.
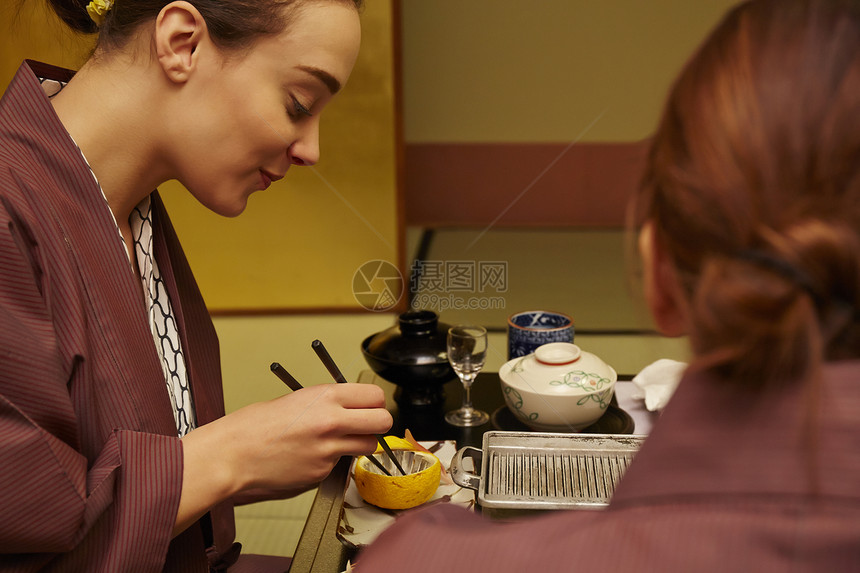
636, 0, 860, 383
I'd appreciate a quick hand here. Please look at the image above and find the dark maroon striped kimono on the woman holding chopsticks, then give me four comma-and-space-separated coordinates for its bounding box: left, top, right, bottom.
0, 62, 238, 572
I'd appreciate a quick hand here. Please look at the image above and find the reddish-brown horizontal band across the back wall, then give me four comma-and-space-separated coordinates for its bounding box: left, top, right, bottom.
406, 141, 647, 227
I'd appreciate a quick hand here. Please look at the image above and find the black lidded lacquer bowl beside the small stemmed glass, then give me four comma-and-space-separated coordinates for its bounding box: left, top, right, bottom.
361, 310, 457, 408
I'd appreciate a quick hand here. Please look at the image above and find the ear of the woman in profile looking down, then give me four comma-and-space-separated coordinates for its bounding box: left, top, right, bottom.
154, 1, 209, 83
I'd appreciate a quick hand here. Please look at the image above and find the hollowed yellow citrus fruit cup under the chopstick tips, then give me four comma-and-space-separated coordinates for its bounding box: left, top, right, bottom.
354, 436, 442, 509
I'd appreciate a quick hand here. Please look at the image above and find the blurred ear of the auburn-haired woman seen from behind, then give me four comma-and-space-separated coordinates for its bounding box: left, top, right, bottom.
639, 221, 687, 336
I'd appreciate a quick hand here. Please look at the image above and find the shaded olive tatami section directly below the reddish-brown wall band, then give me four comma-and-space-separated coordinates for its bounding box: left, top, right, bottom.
411, 229, 653, 331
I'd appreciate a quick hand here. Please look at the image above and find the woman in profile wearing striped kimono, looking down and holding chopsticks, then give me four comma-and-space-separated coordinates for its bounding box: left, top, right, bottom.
0, 0, 391, 573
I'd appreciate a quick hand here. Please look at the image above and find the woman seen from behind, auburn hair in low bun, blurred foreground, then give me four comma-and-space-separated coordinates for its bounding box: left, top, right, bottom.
358, 0, 860, 573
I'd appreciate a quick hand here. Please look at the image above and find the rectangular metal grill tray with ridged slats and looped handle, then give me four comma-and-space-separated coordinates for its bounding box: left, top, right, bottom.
451, 431, 645, 510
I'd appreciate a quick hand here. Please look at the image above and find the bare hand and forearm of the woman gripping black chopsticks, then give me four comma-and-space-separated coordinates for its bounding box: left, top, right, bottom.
174, 384, 392, 535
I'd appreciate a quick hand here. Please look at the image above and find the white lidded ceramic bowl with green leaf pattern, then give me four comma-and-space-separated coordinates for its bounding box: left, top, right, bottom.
499, 342, 618, 432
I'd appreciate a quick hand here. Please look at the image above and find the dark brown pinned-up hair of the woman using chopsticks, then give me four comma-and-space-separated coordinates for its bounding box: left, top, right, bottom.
48, 0, 363, 50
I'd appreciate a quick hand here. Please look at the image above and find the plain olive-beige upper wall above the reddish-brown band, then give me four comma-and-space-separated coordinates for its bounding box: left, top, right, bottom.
403, 0, 736, 143
